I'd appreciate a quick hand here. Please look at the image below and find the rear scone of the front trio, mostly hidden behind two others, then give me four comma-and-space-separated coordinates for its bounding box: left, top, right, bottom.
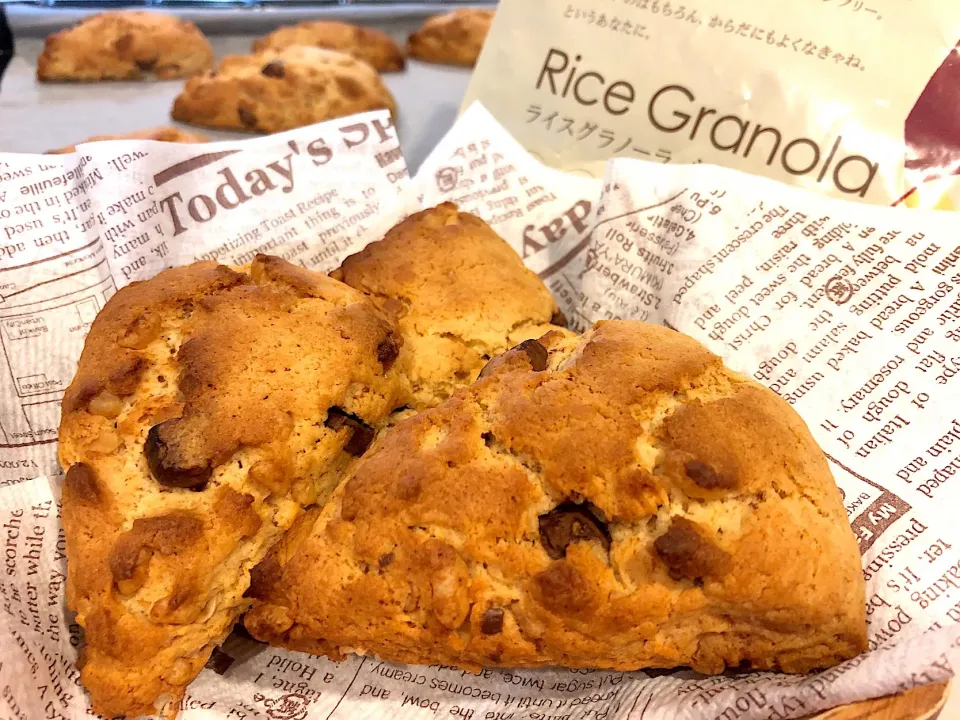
331, 203, 566, 410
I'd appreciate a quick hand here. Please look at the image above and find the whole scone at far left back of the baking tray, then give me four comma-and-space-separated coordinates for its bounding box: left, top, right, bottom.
37, 10, 213, 82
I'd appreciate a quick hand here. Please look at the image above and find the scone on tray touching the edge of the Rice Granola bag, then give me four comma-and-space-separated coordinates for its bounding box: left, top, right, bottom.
407, 8, 494, 67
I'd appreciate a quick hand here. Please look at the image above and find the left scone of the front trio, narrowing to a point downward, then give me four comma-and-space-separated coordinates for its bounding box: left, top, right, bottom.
60, 255, 400, 717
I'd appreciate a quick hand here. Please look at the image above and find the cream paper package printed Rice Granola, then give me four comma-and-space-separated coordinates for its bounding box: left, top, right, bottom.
464, 0, 960, 206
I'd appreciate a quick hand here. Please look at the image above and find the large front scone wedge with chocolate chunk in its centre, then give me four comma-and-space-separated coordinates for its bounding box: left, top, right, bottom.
245, 322, 866, 673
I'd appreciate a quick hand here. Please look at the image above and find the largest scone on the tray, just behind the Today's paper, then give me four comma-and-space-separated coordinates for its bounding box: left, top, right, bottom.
172, 45, 396, 133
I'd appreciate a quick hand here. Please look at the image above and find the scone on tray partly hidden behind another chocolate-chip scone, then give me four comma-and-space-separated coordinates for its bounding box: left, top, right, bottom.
253, 20, 406, 72
